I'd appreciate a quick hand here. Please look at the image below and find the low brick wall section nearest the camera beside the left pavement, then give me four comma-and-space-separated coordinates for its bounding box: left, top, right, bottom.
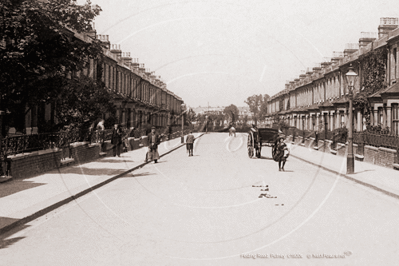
7, 150, 62, 178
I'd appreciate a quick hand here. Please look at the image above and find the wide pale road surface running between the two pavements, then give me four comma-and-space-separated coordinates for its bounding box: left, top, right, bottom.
0, 133, 399, 265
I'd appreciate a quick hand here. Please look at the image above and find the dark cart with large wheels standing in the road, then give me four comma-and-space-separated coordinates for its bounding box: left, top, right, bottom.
247, 128, 278, 158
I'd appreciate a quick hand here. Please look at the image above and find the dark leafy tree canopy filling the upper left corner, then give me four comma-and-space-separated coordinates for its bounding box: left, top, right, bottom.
0, 0, 102, 131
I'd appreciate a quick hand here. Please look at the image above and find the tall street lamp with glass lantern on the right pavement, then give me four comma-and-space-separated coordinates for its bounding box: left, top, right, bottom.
346, 64, 357, 174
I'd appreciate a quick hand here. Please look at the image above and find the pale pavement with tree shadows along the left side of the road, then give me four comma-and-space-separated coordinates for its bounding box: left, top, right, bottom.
0, 133, 202, 235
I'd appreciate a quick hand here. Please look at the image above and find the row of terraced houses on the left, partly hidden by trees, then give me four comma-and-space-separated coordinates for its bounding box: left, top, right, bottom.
20, 28, 183, 135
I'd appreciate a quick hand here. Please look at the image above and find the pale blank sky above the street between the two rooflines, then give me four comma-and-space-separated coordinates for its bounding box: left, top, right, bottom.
78, 0, 399, 107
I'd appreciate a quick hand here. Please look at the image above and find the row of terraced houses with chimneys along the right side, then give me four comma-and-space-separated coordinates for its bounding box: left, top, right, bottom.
266, 18, 399, 135
